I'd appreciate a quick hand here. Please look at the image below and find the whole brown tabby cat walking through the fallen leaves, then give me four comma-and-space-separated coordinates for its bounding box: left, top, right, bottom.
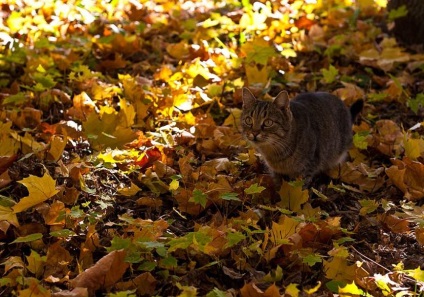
241, 88, 363, 182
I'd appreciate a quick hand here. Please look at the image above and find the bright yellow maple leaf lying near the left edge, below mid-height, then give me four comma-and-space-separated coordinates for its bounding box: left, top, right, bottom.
12, 172, 59, 213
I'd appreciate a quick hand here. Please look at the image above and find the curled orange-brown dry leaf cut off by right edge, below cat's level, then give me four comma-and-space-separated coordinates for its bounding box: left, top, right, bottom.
386, 157, 424, 201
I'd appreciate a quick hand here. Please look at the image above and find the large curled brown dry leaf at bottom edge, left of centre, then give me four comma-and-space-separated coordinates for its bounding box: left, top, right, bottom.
70, 250, 129, 295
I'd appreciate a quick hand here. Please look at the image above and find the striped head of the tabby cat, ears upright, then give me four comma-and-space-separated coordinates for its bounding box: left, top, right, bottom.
241, 88, 292, 146
